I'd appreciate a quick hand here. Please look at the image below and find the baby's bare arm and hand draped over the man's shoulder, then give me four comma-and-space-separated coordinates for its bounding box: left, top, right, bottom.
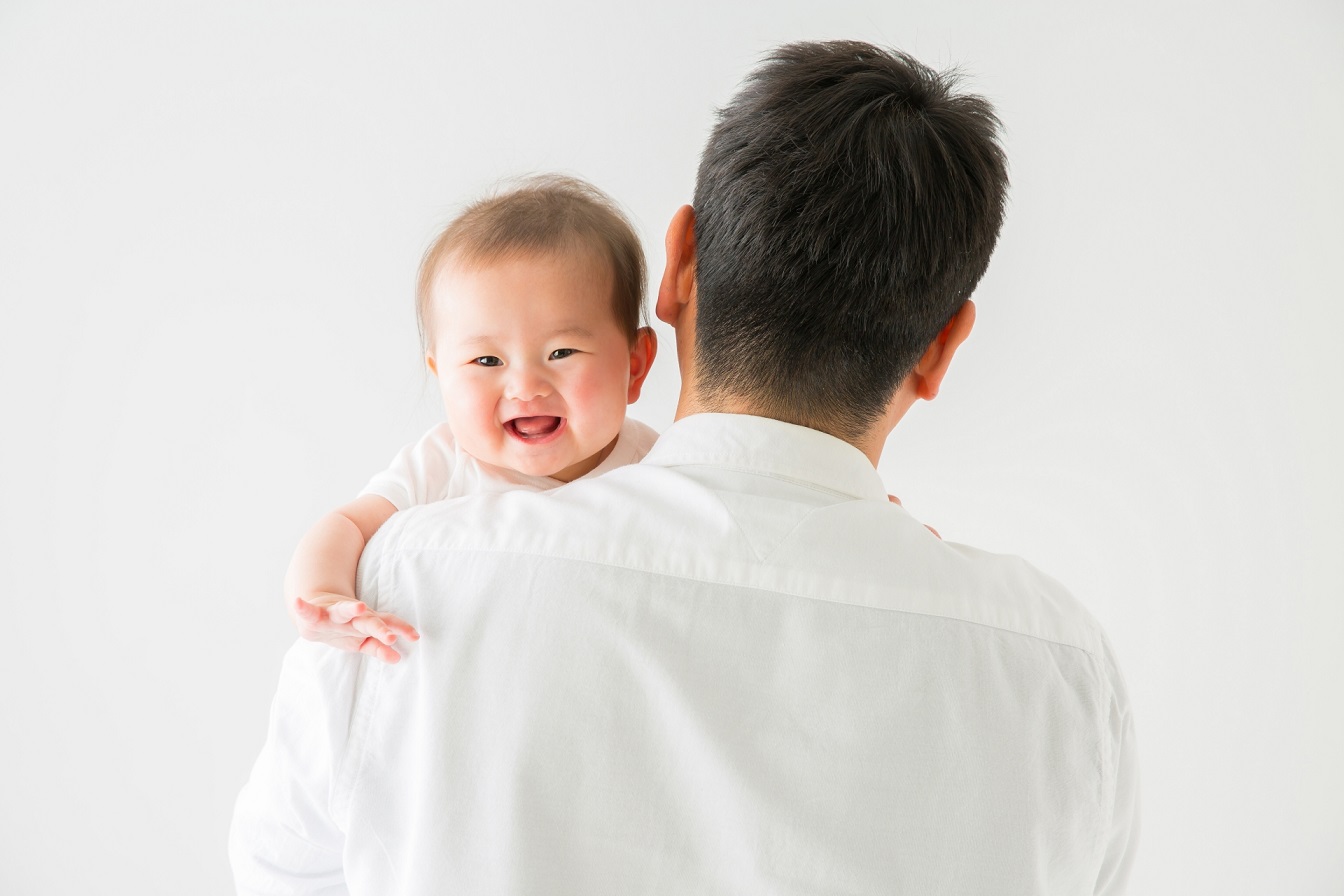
285, 494, 419, 662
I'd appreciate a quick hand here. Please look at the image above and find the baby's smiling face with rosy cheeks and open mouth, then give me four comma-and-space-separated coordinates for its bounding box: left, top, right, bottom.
427, 253, 642, 482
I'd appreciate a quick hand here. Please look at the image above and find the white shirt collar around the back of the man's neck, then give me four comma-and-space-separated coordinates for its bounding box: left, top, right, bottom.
644, 414, 887, 501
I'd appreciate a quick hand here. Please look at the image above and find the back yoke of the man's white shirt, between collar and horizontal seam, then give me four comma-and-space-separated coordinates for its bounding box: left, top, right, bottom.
366, 463, 1103, 656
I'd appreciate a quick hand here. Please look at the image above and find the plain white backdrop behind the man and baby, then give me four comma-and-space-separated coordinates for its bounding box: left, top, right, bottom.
0, 0, 1344, 896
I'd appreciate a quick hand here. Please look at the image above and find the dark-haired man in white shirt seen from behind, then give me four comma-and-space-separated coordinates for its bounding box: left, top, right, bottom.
233, 43, 1137, 893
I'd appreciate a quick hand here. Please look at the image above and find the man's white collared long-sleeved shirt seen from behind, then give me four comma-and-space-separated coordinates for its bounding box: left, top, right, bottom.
231, 415, 1137, 896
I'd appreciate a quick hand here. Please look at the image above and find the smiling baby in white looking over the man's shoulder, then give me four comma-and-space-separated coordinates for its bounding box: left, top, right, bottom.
285, 176, 657, 662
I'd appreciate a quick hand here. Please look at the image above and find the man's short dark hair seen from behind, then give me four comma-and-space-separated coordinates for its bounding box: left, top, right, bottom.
695, 42, 1008, 441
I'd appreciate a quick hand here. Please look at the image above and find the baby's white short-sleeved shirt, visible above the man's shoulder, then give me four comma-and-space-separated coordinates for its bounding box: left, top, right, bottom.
362, 418, 659, 510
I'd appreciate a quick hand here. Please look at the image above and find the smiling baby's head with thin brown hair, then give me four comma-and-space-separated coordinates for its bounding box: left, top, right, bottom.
417, 175, 656, 482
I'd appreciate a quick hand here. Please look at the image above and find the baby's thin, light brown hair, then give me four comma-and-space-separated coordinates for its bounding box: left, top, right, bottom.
415, 175, 645, 351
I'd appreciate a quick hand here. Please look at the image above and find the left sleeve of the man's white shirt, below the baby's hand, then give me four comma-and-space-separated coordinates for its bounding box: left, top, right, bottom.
228, 641, 362, 896
